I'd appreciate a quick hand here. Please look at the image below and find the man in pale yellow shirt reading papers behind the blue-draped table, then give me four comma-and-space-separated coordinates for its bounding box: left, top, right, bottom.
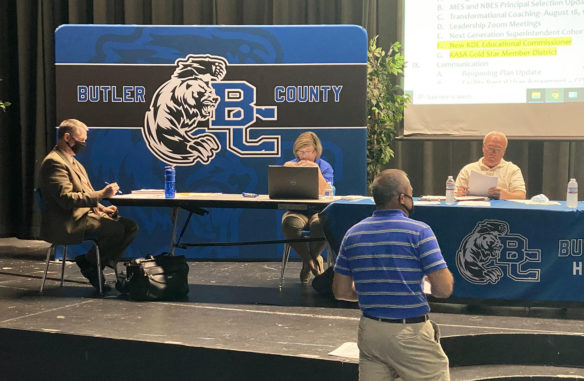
455, 131, 526, 200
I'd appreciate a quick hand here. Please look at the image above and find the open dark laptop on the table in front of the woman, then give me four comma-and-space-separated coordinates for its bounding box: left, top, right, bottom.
268, 165, 318, 199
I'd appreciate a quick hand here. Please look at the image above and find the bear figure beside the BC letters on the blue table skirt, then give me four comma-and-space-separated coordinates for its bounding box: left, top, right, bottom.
456, 220, 509, 284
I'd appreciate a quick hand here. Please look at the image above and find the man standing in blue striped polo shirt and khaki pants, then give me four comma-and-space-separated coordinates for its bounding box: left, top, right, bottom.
333, 169, 453, 381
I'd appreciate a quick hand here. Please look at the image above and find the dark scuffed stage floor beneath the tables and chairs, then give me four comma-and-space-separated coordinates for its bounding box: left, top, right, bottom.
0, 238, 584, 380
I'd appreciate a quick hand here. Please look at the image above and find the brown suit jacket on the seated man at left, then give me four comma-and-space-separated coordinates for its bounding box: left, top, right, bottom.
39, 147, 99, 244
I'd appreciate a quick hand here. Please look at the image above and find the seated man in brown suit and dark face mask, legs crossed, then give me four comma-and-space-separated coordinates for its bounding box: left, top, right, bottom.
39, 119, 138, 288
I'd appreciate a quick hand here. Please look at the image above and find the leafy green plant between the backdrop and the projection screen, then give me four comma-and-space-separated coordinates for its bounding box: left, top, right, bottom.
367, 36, 410, 186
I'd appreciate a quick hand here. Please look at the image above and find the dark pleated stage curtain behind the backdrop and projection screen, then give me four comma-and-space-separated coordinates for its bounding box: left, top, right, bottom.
0, 0, 584, 238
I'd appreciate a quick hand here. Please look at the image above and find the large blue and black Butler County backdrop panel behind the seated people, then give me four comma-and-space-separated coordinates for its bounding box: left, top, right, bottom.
55, 25, 367, 259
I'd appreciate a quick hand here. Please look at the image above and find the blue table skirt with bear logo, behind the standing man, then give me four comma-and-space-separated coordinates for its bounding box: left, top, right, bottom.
321, 199, 584, 302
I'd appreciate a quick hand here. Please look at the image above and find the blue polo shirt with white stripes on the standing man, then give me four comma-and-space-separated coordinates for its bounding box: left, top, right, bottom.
335, 209, 447, 319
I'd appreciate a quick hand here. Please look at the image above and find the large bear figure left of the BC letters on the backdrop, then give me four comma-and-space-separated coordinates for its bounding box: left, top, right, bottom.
142, 54, 227, 165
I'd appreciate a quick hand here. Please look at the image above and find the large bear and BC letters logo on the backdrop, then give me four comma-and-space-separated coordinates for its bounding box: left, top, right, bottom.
142, 54, 280, 165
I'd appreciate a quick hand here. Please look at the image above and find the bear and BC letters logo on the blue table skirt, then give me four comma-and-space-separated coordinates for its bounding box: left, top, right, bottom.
456, 220, 541, 284
